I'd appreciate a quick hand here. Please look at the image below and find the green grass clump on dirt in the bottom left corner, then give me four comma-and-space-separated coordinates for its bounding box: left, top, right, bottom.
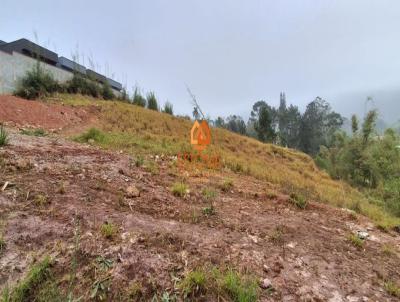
3, 257, 51, 302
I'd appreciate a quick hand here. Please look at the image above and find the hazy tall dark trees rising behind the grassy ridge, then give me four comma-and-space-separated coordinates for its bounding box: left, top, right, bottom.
213, 93, 344, 156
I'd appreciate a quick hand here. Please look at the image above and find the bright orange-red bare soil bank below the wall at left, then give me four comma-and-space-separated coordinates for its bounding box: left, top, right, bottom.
0, 95, 92, 130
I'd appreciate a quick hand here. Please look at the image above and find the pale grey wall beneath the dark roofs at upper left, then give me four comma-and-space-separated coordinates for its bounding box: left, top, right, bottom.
0, 51, 120, 97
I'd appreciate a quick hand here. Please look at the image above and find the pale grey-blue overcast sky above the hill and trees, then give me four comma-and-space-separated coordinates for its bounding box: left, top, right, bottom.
0, 0, 400, 119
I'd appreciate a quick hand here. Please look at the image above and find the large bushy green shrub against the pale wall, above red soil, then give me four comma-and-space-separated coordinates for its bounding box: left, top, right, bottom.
15, 62, 61, 99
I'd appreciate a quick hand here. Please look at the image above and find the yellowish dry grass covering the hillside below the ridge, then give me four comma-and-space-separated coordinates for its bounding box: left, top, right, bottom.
57, 95, 400, 228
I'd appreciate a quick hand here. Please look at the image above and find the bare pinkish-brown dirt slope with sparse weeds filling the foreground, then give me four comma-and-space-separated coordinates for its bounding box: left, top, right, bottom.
0, 131, 400, 301
